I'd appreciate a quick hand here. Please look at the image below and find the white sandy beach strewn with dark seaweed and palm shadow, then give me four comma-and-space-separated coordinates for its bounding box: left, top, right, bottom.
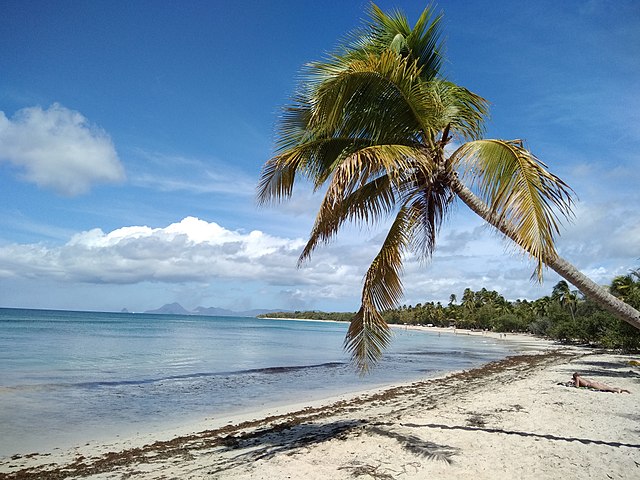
0, 336, 640, 480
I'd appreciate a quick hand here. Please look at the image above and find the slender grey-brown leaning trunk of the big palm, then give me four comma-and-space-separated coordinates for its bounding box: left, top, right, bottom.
451, 178, 640, 329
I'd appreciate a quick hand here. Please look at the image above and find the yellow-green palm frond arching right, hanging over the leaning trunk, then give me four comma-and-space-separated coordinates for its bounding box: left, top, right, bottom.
451, 140, 573, 281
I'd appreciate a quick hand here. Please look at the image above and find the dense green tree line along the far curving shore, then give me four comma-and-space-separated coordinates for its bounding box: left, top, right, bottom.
264, 269, 640, 351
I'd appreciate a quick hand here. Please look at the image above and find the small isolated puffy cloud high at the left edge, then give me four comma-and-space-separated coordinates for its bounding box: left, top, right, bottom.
0, 103, 124, 196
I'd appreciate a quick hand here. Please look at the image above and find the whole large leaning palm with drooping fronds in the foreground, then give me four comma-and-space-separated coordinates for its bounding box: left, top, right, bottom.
258, 4, 640, 372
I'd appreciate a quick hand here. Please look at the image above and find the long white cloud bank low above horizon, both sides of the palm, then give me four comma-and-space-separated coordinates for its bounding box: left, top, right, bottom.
0, 201, 640, 310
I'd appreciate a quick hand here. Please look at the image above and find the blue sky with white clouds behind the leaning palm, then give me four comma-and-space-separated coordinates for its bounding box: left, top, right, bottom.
0, 0, 640, 311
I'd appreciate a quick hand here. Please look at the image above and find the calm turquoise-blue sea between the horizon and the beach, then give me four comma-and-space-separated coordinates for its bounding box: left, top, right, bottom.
0, 309, 510, 456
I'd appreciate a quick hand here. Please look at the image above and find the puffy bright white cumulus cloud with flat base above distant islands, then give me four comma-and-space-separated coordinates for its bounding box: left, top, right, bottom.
0, 217, 312, 284
